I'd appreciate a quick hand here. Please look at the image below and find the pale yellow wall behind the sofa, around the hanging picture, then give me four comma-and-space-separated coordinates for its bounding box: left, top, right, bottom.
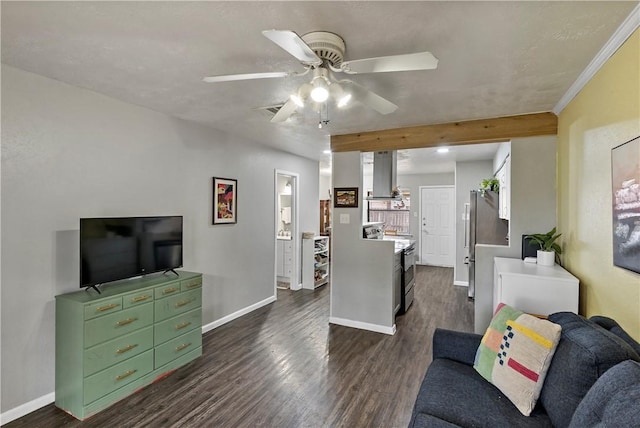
558, 29, 640, 340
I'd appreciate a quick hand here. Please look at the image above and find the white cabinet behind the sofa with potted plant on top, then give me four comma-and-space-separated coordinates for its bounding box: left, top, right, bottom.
493, 257, 579, 316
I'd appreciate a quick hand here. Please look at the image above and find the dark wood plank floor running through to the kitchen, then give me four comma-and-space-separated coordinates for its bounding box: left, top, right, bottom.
6, 266, 473, 428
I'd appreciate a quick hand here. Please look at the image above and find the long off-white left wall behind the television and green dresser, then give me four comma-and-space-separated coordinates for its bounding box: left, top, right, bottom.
1, 65, 319, 413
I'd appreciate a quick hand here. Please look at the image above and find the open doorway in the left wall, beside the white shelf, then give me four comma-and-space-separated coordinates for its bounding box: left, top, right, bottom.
274, 170, 302, 296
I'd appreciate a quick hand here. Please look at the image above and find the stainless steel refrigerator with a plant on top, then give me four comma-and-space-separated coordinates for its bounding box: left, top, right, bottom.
465, 190, 509, 299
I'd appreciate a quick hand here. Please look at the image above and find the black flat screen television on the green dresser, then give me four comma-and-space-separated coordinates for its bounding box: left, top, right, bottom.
80, 216, 182, 292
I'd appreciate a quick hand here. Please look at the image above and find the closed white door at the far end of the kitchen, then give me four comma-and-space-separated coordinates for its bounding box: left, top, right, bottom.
420, 186, 456, 266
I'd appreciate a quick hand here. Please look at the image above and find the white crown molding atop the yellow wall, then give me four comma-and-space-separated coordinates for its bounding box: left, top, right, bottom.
552, 4, 640, 115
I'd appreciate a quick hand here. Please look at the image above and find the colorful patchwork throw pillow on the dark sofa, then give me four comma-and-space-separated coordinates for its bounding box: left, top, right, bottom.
473, 303, 561, 416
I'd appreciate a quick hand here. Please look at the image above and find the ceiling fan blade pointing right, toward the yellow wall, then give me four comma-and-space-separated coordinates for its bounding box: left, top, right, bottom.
340, 52, 438, 74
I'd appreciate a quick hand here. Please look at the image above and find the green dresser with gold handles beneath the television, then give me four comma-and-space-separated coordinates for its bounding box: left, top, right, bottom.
56, 271, 202, 420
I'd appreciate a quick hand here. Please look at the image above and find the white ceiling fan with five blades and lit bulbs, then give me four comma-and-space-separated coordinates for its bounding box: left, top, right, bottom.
203, 30, 438, 123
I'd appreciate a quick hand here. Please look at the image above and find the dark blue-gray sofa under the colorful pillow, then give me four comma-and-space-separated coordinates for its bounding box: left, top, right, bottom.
409, 312, 640, 428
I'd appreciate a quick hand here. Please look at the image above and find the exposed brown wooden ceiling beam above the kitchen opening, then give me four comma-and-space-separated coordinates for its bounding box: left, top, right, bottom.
331, 112, 558, 152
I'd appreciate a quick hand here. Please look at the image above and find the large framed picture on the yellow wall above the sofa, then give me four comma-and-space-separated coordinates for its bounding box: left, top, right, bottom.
611, 137, 640, 273
